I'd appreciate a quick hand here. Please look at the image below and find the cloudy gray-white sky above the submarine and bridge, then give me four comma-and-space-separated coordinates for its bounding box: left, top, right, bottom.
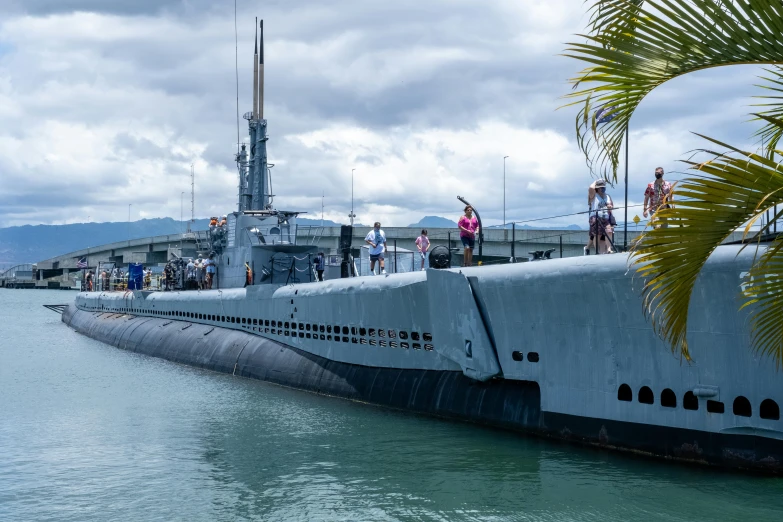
0, 0, 772, 226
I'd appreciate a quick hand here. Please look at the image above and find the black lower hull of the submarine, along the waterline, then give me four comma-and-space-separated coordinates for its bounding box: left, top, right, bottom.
63, 305, 783, 473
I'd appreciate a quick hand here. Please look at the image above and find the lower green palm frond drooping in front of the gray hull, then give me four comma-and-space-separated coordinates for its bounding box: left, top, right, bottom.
631, 136, 783, 363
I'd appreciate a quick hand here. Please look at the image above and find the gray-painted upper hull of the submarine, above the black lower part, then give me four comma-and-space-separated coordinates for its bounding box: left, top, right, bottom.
76, 246, 783, 444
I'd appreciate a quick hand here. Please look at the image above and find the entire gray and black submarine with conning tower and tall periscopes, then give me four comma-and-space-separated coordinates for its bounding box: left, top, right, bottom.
62, 21, 783, 474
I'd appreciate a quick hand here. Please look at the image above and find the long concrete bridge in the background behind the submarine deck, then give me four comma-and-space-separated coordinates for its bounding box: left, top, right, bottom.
24, 222, 742, 287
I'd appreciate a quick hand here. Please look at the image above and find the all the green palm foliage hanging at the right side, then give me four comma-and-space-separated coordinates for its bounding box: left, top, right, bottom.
565, 0, 783, 365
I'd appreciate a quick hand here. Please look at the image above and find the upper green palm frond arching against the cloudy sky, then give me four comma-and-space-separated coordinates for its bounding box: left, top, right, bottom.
564, 0, 783, 180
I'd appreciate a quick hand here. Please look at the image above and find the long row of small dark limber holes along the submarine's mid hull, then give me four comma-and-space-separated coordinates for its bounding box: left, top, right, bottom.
87, 307, 440, 351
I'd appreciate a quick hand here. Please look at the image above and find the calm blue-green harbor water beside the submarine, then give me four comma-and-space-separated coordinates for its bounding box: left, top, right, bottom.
0, 289, 783, 522
